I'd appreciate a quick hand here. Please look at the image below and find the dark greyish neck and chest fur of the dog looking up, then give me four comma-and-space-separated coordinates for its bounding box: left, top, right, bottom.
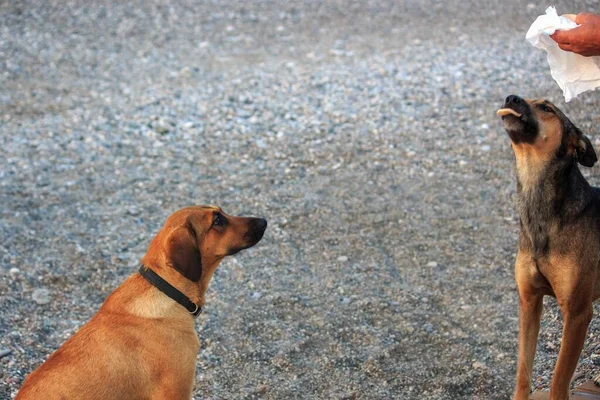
517, 156, 592, 258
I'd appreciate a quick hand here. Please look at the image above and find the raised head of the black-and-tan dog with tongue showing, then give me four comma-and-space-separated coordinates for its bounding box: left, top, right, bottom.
497, 95, 598, 167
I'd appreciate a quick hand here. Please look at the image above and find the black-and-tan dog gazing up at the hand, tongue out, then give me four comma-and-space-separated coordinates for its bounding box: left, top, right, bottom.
498, 95, 600, 400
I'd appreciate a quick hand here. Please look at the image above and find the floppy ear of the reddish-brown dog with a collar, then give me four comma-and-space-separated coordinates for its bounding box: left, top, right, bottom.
166, 224, 202, 282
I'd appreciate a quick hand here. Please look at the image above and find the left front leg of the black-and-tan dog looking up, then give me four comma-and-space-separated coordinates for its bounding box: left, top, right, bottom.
514, 292, 544, 400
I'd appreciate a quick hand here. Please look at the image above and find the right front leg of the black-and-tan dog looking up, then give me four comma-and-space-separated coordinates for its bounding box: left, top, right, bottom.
550, 301, 593, 400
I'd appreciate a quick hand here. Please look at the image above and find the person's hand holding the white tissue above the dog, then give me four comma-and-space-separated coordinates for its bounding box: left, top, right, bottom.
550, 13, 600, 57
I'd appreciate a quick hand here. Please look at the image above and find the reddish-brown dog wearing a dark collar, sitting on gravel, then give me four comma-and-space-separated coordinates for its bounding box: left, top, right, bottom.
17, 207, 267, 400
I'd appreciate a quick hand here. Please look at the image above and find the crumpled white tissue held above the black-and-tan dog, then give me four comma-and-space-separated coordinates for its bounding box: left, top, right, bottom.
525, 7, 600, 102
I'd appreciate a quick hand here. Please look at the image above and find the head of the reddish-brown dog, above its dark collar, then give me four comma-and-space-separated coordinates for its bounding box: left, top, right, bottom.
142, 206, 267, 286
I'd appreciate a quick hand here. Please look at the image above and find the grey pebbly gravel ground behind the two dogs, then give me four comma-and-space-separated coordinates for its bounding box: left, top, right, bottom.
0, 0, 600, 399
